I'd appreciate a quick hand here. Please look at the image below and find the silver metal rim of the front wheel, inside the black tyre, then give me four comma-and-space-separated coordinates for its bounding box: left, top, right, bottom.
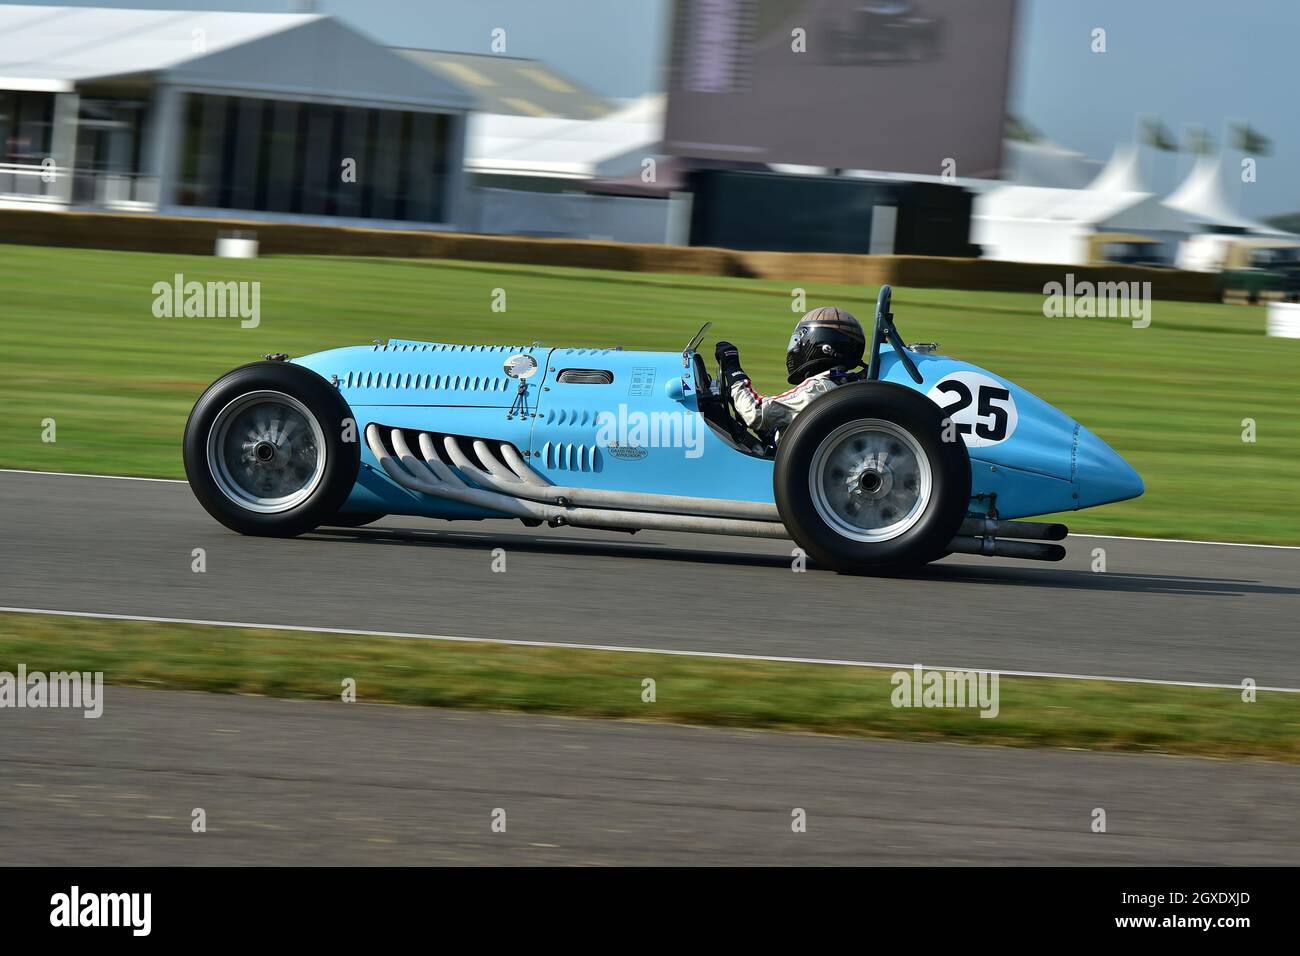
208, 392, 325, 514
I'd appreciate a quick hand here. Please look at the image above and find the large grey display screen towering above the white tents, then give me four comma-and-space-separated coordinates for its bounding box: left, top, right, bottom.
664, 0, 1015, 177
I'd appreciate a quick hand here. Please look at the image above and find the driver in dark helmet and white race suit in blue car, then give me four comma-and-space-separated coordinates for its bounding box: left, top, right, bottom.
714, 306, 867, 433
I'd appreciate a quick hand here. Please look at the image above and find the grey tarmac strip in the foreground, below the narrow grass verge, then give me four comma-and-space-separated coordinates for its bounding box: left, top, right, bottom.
0, 687, 1300, 866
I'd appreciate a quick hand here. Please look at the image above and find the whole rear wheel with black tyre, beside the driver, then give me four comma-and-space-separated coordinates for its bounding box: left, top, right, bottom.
774, 382, 971, 574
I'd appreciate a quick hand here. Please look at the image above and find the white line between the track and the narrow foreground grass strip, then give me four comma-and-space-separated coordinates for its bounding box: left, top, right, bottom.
0, 606, 1300, 693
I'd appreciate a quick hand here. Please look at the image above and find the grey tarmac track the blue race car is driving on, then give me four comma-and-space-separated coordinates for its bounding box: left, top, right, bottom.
0, 472, 1300, 688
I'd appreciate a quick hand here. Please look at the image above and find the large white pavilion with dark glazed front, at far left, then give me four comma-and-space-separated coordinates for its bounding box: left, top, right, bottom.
0, 5, 473, 228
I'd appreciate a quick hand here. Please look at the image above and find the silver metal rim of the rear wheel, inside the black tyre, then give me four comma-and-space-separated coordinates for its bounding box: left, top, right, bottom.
809, 419, 933, 542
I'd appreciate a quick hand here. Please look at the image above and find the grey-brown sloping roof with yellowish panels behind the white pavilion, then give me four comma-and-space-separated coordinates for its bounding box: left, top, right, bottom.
394, 47, 616, 120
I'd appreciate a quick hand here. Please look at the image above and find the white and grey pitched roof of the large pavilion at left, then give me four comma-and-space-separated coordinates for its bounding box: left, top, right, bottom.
0, 5, 473, 109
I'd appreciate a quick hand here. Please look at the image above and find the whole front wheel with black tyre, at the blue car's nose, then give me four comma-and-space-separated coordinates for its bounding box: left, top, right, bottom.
185, 362, 361, 537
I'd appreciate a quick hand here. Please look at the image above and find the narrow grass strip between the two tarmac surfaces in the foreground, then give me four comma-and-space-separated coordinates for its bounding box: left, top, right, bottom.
0, 614, 1300, 762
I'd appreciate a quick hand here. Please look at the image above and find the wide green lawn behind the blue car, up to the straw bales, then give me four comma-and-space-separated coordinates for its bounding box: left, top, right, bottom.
0, 246, 1300, 544
